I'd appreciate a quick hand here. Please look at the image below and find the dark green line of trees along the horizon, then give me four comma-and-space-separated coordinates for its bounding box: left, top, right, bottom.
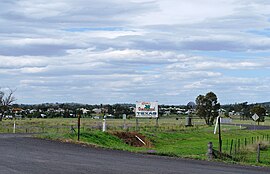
0, 88, 270, 125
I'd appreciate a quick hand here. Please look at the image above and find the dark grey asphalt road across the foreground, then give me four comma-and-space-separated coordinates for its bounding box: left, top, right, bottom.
0, 134, 270, 174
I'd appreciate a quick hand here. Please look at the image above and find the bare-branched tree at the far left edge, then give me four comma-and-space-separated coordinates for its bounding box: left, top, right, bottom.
0, 89, 16, 121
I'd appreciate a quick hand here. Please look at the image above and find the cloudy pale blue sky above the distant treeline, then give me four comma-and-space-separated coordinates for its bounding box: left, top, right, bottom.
0, 0, 270, 104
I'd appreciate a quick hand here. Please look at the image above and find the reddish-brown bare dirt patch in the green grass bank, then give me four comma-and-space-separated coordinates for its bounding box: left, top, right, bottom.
113, 132, 152, 147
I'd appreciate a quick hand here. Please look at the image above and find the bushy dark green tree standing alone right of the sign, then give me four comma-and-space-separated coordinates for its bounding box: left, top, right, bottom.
196, 92, 220, 126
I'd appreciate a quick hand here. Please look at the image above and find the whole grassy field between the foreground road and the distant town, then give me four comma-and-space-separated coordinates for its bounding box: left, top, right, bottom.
0, 118, 270, 166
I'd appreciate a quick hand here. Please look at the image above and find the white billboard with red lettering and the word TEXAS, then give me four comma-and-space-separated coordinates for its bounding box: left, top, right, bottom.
136, 102, 158, 118
